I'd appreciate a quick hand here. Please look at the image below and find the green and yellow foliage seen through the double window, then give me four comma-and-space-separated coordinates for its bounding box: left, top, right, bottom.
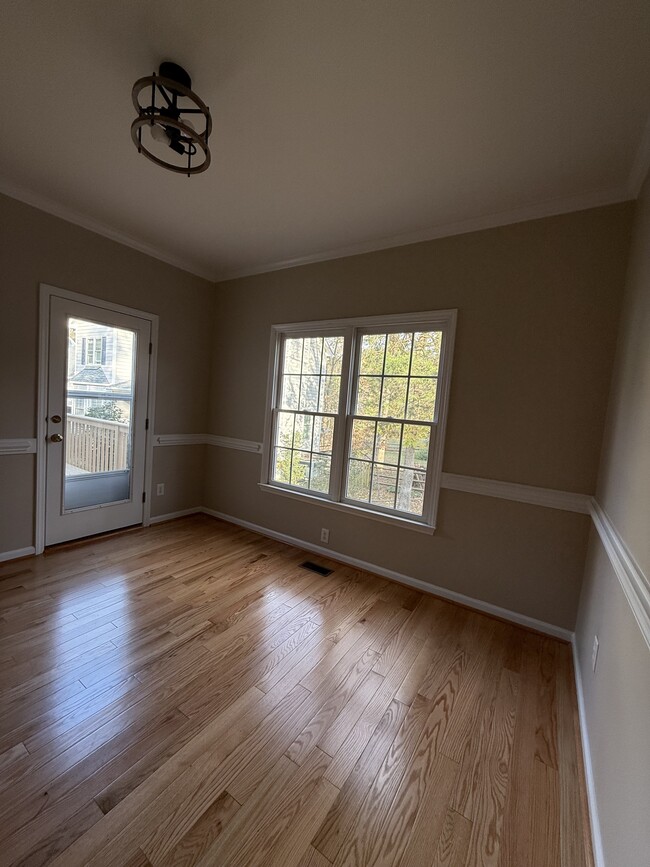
273, 331, 442, 514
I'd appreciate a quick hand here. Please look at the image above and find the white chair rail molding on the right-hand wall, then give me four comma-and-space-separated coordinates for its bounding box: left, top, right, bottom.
591, 498, 650, 649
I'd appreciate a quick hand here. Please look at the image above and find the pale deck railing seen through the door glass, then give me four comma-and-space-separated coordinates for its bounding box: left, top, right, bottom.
65, 415, 129, 473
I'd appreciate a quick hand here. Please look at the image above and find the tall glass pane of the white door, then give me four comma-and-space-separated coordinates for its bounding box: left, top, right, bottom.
61, 316, 136, 510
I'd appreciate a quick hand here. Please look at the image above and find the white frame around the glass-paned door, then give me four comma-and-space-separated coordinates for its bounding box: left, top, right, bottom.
34, 283, 159, 554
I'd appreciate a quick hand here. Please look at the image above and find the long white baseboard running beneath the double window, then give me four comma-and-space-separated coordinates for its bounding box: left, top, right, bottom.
201, 508, 573, 642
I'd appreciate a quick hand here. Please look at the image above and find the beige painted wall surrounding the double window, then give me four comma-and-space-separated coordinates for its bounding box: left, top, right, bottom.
206, 204, 632, 628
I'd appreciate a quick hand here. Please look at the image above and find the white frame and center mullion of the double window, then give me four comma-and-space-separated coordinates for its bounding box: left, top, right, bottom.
260, 310, 457, 533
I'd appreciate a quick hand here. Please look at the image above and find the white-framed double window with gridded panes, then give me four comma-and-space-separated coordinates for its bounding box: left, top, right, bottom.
262, 310, 456, 530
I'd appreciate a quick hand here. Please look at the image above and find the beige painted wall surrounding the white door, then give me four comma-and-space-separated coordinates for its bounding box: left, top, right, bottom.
0, 196, 214, 551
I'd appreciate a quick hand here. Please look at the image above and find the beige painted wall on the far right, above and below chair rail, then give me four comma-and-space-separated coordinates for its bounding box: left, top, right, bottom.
576, 175, 650, 867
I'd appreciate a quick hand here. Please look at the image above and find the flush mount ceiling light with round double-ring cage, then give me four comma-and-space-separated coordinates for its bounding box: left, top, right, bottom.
131, 62, 212, 177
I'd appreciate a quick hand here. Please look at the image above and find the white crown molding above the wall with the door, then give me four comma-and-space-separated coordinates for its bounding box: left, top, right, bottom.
0, 177, 215, 283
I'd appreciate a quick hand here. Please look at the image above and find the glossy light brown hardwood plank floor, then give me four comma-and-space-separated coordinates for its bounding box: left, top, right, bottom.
0, 517, 592, 867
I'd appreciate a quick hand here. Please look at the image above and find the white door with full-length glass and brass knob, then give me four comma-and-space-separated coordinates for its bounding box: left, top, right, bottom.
45, 295, 151, 545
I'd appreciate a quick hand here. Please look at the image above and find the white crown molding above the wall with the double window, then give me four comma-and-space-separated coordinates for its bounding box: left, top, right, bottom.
215, 187, 635, 283
